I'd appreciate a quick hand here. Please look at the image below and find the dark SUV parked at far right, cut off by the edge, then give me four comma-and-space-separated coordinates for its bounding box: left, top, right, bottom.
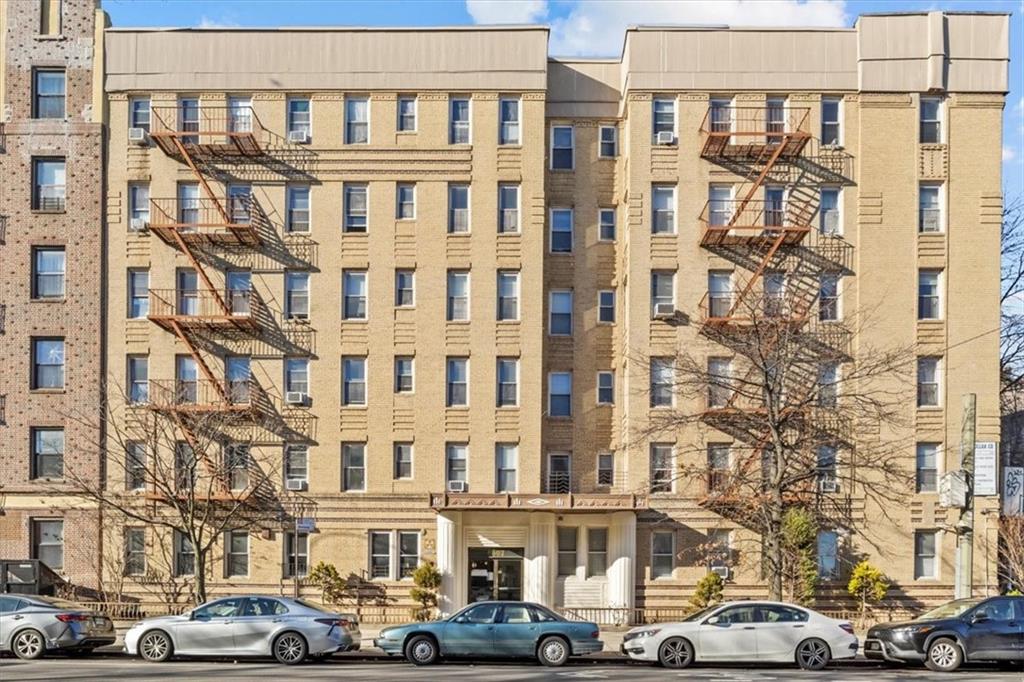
864, 597, 1024, 672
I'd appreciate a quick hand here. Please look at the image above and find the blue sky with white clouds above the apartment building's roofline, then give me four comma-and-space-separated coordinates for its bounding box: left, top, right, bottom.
102, 0, 1024, 196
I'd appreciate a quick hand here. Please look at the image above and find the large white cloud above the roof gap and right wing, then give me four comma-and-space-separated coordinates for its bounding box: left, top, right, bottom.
550, 0, 850, 56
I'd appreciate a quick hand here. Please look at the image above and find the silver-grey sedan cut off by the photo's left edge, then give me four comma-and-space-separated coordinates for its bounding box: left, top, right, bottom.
0, 594, 117, 660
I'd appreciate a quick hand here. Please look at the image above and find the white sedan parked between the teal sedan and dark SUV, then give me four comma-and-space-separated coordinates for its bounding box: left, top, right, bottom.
622, 601, 858, 670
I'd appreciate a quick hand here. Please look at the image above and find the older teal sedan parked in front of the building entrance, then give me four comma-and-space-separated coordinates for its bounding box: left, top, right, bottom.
374, 601, 604, 666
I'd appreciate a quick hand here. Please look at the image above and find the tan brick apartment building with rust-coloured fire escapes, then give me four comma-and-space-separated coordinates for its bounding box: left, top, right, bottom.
4, 2, 1009, 611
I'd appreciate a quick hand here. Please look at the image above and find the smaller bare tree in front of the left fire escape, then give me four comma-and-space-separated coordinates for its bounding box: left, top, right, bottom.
60, 382, 309, 603
